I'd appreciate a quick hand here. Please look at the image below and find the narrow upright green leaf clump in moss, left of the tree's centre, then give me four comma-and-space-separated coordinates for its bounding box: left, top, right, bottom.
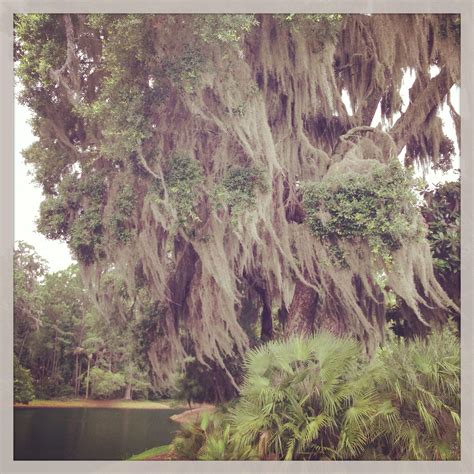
165, 153, 204, 228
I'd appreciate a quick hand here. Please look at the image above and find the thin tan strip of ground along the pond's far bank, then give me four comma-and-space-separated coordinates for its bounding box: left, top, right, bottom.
14, 398, 185, 410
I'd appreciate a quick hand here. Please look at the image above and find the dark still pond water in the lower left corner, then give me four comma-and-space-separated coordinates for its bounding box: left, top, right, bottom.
14, 408, 182, 460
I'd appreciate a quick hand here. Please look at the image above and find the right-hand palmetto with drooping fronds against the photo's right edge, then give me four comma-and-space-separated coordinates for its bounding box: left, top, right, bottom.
372, 325, 461, 460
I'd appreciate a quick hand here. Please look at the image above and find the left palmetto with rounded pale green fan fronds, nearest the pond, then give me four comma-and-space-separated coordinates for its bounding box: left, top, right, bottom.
231, 333, 370, 459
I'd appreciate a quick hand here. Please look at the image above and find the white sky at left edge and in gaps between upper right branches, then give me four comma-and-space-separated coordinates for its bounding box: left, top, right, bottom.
14, 73, 460, 272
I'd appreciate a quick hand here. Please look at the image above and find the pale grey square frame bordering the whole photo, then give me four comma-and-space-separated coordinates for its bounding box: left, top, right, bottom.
0, 0, 474, 474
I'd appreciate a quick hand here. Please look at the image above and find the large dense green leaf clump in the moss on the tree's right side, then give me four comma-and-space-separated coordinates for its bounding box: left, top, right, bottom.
303, 160, 422, 262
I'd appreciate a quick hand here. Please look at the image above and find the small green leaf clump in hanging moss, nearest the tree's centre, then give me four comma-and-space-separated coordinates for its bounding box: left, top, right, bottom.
214, 167, 269, 217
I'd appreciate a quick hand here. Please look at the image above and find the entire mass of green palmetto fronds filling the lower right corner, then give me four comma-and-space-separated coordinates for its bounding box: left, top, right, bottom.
225, 327, 460, 460
